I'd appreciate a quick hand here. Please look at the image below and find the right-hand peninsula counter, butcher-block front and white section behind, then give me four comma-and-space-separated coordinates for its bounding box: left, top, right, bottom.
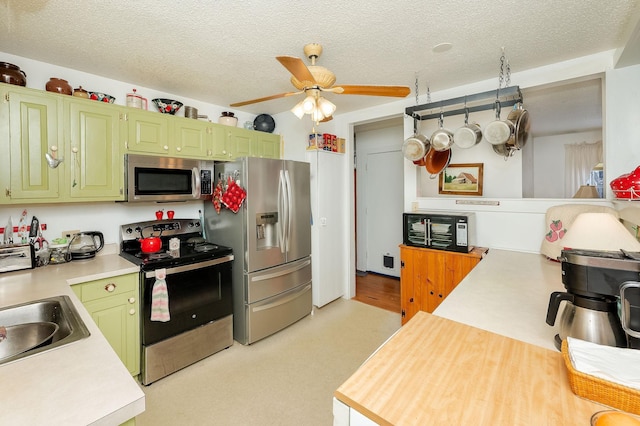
334, 250, 604, 426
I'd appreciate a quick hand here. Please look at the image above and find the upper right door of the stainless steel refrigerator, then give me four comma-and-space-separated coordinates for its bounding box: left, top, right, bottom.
283, 160, 311, 262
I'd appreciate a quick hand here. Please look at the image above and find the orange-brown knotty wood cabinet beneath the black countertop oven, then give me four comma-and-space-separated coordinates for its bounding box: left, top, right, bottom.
400, 245, 486, 324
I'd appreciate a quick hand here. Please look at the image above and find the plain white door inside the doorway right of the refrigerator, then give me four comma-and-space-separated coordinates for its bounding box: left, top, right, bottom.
359, 151, 404, 277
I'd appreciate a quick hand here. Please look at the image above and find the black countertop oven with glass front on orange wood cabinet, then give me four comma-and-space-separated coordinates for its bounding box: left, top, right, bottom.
402, 212, 476, 253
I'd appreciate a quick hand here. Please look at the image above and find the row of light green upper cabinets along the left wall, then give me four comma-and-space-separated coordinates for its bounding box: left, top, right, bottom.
0, 84, 280, 204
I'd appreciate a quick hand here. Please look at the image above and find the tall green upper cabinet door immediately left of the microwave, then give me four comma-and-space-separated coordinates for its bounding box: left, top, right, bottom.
64, 97, 124, 201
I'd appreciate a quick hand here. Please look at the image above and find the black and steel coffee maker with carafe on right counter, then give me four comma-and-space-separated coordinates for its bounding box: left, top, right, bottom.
547, 249, 640, 350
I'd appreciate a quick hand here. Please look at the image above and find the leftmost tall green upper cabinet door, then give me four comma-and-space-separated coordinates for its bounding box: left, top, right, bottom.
4, 89, 65, 202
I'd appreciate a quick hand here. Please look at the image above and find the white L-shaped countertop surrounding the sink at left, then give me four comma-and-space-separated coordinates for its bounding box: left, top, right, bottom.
0, 247, 145, 425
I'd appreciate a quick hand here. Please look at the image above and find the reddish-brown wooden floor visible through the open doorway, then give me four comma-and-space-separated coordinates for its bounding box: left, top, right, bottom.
353, 272, 400, 313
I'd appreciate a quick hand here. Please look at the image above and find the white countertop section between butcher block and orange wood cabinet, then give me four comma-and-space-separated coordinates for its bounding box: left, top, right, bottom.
433, 249, 565, 351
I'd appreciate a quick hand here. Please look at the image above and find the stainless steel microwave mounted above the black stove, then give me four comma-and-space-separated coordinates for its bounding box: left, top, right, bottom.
125, 154, 214, 202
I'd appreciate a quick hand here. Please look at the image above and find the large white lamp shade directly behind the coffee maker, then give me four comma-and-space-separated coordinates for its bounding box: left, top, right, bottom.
562, 213, 640, 251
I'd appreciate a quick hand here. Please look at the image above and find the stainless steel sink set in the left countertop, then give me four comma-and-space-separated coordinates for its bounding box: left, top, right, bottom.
0, 296, 90, 364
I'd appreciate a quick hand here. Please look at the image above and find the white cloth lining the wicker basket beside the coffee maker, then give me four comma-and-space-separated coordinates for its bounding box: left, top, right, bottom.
567, 337, 640, 390
